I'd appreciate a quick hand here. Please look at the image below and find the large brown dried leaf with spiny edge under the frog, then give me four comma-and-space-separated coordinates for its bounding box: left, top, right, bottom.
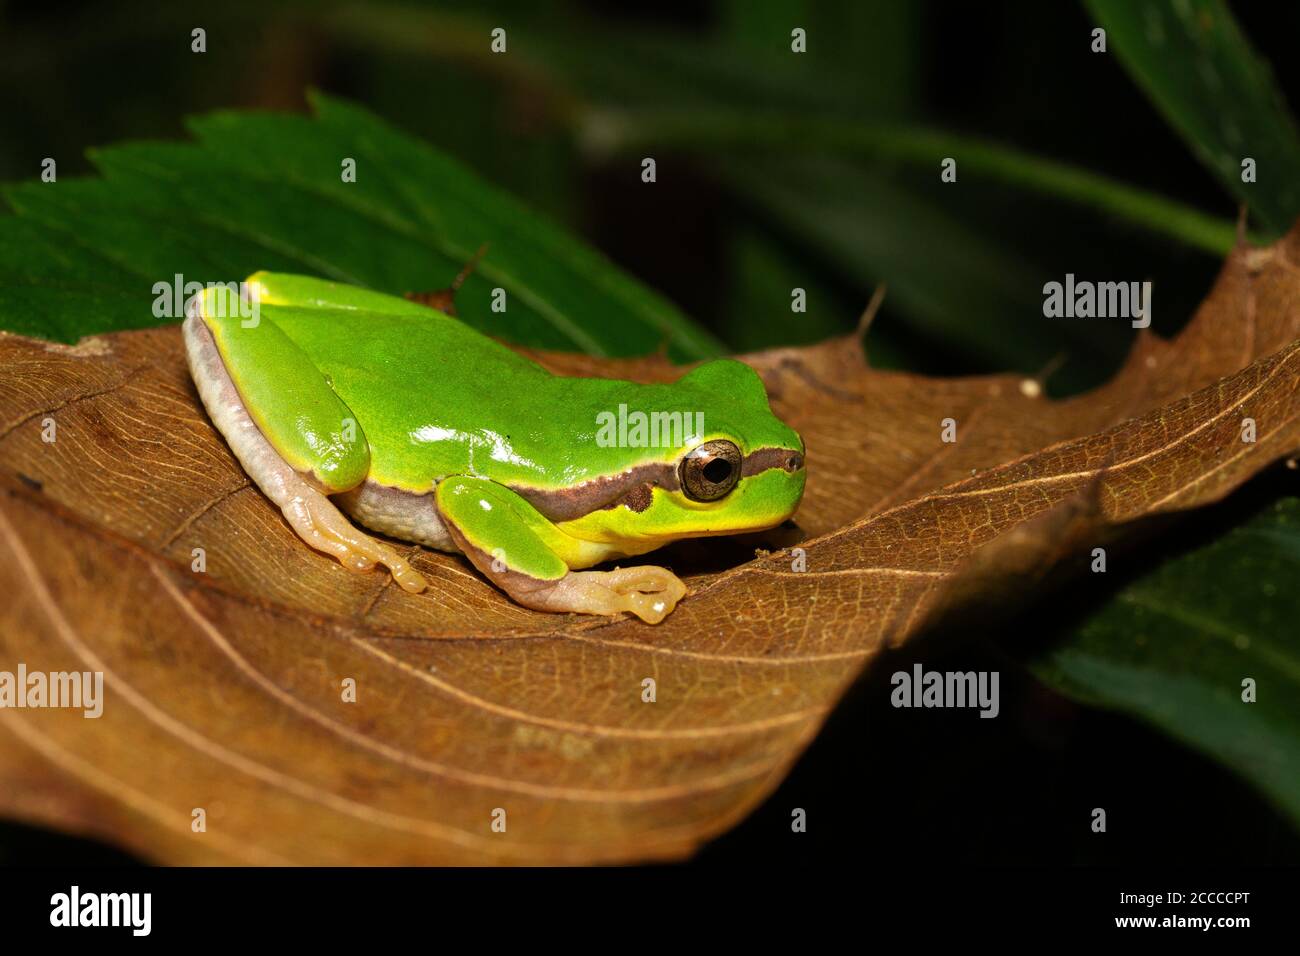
0, 233, 1300, 864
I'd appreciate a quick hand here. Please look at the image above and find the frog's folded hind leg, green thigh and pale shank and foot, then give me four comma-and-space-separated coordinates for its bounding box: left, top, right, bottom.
185, 297, 425, 592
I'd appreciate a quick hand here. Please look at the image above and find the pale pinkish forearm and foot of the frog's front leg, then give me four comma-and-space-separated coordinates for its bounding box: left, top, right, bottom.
502, 564, 686, 624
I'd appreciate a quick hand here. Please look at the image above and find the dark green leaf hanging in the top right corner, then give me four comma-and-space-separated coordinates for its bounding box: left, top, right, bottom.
1084, 0, 1300, 233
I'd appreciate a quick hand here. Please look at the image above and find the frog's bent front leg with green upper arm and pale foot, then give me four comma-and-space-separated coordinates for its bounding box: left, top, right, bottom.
436, 475, 686, 624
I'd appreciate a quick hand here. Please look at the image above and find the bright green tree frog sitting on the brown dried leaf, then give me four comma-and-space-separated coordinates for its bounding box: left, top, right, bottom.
183, 272, 805, 623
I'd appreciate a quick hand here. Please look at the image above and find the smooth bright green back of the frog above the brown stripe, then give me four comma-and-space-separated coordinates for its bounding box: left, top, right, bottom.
250, 273, 801, 490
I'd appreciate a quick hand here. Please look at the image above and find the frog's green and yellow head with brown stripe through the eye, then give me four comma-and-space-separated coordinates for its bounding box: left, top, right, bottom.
551, 359, 806, 550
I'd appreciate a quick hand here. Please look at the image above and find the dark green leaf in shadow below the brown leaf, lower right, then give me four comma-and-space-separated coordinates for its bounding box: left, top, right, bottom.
1031, 498, 1300, 825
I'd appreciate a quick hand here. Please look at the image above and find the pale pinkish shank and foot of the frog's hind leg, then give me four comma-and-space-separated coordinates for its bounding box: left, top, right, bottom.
183, 298, 425, 592
